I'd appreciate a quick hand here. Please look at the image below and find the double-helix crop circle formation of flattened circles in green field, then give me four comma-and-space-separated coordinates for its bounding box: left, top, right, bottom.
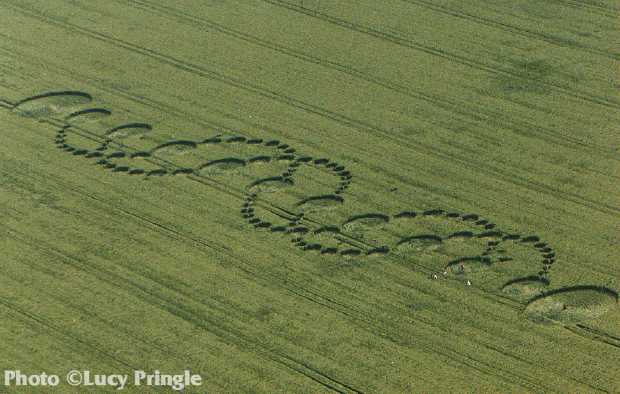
7, 91, 618, 323
